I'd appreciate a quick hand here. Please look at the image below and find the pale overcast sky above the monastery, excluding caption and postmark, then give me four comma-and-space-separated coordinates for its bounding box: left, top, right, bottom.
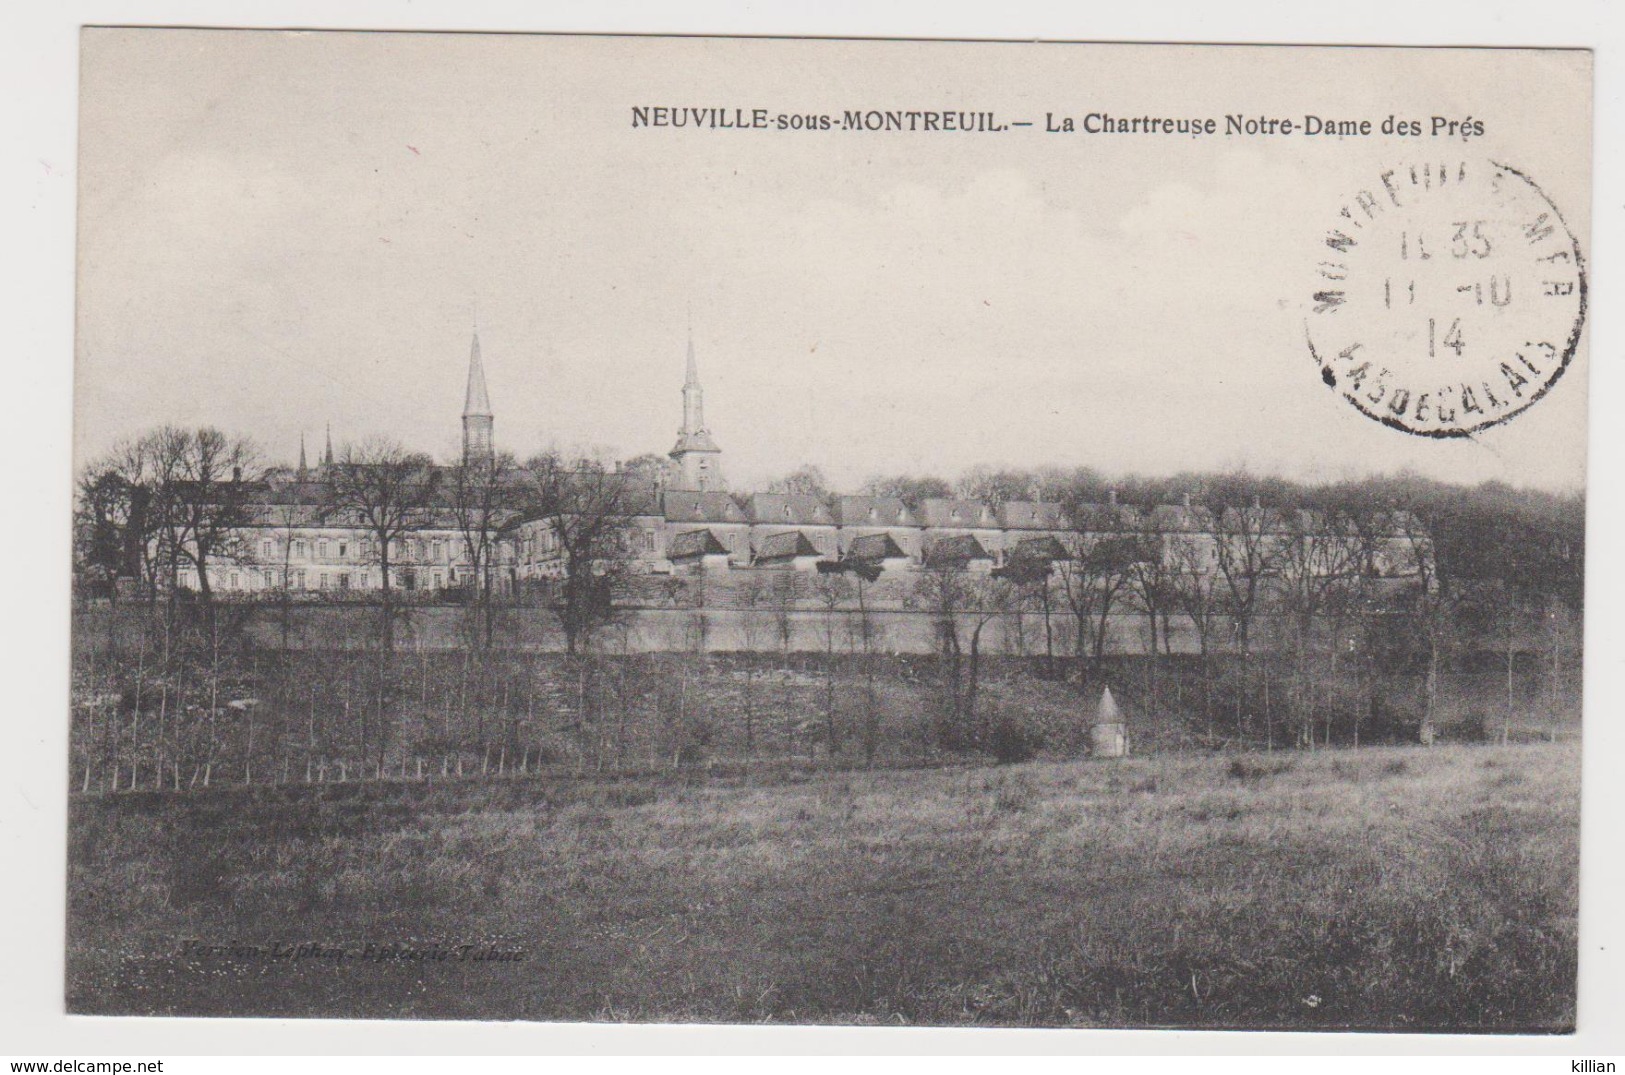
76, 31, 1591, 489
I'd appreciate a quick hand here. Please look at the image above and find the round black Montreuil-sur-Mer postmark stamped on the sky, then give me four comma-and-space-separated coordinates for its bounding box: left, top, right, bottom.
1305, 161, 1586, 437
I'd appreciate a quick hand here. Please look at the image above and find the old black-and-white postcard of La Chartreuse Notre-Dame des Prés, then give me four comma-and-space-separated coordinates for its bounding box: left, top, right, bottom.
73, 28, 1593, 1032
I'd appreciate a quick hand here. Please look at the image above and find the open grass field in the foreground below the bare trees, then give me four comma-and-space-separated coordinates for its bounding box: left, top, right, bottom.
68, 742, 1580, 1031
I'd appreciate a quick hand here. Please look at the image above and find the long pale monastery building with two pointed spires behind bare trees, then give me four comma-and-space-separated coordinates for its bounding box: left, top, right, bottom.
177, 335, 1425, 620
